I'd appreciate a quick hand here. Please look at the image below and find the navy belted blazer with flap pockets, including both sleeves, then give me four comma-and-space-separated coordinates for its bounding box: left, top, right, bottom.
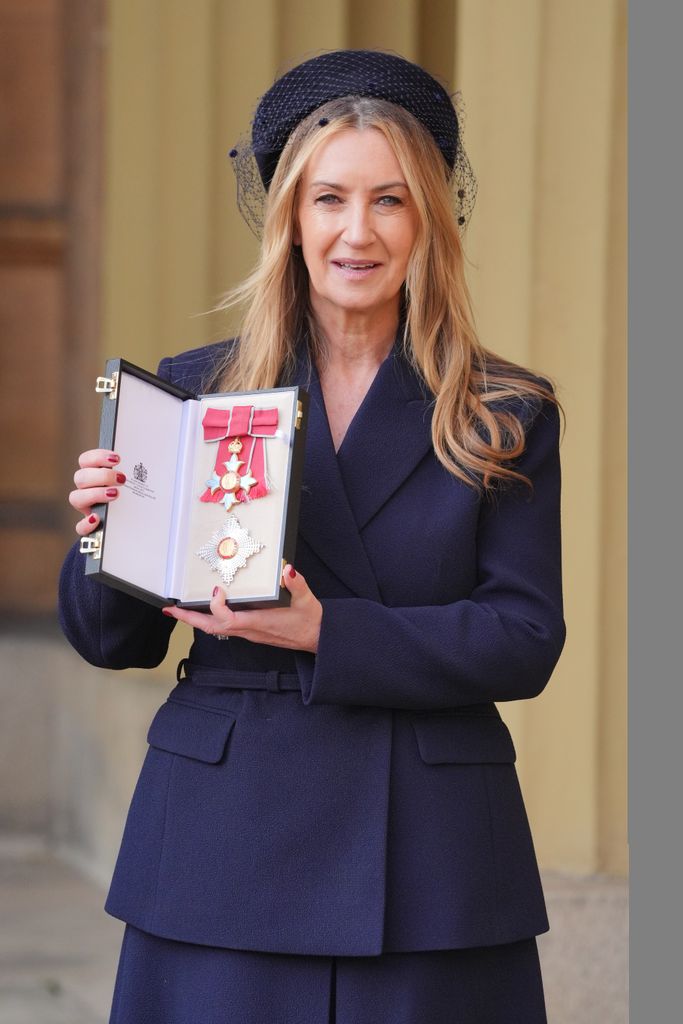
59, 343, 564, 955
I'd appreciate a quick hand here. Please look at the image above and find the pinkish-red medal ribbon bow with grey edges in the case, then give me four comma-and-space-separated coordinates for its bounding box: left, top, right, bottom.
200, 406, 279, 503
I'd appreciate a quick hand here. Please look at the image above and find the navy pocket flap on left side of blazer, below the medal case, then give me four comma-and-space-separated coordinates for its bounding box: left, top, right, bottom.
147, 700, 234, 764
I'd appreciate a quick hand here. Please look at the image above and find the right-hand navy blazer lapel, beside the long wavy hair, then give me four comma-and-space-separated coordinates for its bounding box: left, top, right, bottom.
337, 341, 433, 530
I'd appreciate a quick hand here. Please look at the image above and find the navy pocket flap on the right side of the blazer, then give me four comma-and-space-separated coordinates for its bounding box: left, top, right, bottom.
412, 715, 516, 765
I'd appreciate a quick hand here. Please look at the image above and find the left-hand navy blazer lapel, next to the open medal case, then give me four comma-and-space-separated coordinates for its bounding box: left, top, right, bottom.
294, 348, 381, 601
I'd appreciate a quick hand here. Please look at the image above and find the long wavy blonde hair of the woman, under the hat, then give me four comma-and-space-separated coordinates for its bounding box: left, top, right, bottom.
214, 96, 561, 492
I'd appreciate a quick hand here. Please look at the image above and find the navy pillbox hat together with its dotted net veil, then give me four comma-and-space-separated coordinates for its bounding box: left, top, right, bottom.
229, 50, 477, 238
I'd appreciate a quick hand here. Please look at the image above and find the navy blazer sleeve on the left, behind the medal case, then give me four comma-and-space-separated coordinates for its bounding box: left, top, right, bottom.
58, 358, 175, 669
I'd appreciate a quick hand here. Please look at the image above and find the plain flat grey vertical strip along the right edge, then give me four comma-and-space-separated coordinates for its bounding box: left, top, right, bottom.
630, 0, 683, 1024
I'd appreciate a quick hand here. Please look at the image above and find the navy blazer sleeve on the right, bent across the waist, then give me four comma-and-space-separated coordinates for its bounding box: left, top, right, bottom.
297, 401, 565, 710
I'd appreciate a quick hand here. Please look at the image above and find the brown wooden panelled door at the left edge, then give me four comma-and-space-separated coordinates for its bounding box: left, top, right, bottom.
0, 0, 104, 627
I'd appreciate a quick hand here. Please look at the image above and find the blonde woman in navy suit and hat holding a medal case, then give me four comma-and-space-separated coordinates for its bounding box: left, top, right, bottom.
60, 51, 564, 1024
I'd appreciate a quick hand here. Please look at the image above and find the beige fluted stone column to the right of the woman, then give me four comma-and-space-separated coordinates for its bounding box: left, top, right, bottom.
456, 0, 628, 874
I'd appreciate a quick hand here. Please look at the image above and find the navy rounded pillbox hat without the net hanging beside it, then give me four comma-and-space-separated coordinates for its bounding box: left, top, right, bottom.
252, 50, 460, 190
